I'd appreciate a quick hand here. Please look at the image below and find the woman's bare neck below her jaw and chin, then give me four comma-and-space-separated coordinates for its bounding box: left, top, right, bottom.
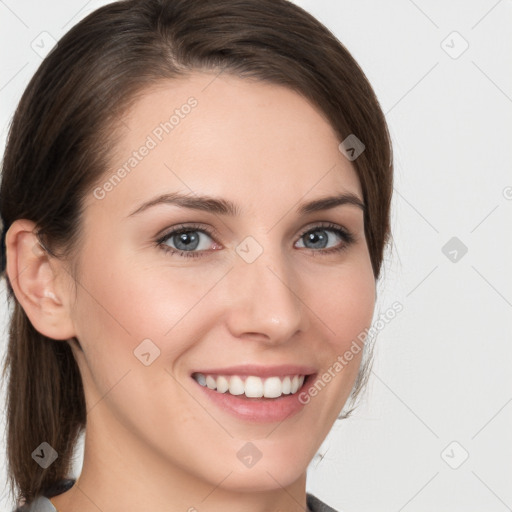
52, 414, 308, 512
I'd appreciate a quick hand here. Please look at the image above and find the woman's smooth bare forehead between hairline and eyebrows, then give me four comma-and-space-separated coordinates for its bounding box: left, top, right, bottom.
85, 73, 362, 218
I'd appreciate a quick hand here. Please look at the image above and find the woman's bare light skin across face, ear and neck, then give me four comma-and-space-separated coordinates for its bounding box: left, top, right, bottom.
7, 72, 375, 512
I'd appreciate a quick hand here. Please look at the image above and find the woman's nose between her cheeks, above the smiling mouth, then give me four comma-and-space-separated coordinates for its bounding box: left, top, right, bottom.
227, 244, 309, 344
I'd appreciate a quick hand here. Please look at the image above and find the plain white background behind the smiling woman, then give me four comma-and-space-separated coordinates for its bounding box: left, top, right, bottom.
0, 0, 512, 512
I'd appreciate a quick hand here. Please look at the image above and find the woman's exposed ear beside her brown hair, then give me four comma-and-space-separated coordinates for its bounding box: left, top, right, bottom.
5, 219, 75, 340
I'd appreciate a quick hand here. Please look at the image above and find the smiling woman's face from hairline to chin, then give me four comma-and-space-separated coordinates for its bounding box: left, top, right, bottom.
66, 73, 375, 490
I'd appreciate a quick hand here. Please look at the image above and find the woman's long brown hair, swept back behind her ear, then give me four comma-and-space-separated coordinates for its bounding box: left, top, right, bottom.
0, 0, 393, 502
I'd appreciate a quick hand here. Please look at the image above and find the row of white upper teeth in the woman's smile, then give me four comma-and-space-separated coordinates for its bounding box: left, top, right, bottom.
193, 373, 305, 398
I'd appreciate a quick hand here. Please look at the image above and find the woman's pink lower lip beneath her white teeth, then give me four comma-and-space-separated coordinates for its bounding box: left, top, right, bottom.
192, 375, 313, 423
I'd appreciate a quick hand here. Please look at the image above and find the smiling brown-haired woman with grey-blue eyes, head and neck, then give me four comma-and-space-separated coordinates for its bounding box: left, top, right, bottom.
0, 0, 392, 512
